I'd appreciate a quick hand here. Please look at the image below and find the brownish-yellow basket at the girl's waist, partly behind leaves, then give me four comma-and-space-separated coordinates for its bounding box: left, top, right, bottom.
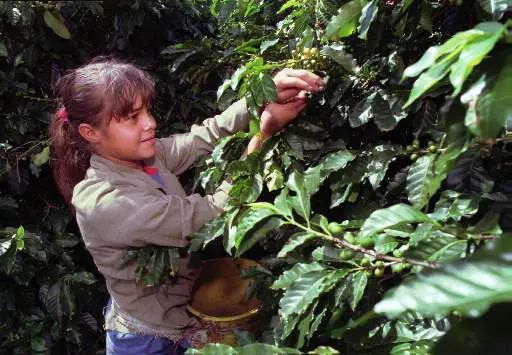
187, 258, 260, 345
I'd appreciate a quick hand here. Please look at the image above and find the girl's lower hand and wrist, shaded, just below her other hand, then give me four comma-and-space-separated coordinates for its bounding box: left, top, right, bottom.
260, 96, 307, 140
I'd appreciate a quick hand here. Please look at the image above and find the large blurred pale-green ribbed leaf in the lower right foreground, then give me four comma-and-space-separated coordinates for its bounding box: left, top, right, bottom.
374, 238, 512, 318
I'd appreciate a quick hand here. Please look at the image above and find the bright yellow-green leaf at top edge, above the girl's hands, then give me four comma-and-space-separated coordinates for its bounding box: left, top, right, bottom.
325, 0, 366, 41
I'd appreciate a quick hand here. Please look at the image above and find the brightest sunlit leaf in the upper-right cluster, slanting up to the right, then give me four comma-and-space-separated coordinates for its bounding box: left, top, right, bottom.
450, 22, 506, 96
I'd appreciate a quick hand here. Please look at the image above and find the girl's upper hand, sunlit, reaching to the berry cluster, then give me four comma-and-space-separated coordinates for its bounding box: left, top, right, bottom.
274, 69, 324, 104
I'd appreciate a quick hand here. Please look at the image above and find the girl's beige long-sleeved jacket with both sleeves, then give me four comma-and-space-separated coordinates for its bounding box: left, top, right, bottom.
72, 100, 249, 330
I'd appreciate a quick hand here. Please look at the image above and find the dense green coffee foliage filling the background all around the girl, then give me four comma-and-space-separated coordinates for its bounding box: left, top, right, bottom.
0, 0, 512, 354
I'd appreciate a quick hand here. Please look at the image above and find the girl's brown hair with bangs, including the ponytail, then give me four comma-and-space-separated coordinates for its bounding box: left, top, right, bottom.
49, 57, 154, 206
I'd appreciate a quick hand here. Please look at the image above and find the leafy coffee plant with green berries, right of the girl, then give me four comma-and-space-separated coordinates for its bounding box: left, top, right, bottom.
184, 0, 512, 354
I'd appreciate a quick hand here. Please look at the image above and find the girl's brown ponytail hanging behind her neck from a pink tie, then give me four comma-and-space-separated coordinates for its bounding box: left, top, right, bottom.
49, 109, 91, 207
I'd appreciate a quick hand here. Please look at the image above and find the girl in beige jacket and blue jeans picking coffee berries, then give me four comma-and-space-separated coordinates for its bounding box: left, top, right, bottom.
50, 58, 322, 354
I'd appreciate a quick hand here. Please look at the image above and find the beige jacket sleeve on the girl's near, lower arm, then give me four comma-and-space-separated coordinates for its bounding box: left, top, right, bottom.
76, 182, 231, 248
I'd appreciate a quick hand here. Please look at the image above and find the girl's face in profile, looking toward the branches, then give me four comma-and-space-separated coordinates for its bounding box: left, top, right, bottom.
95, 97, 156, 168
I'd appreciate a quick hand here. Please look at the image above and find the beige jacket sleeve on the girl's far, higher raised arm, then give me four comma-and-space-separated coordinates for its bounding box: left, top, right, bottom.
157, 99, 250, 175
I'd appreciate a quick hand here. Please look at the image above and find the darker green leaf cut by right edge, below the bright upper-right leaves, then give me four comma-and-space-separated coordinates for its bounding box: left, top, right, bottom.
472, 55, 512, 140
